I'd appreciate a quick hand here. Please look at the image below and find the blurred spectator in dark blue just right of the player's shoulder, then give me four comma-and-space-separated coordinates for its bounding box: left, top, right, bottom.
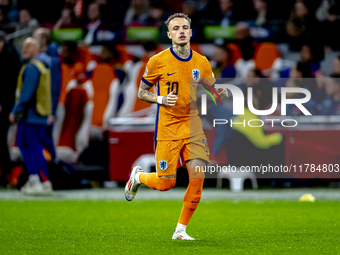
211, 44, 236, 80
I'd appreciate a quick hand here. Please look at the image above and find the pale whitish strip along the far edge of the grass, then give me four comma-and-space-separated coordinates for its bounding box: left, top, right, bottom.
0, 188, 340, 201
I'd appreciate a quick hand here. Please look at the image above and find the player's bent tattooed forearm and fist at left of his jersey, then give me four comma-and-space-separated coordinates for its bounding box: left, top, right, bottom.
138, 81, 178, 106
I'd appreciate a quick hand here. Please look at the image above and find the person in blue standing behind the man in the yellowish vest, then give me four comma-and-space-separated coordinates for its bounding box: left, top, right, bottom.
34, 28, 61, 161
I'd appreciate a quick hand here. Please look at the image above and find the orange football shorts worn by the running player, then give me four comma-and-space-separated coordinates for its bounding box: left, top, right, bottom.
155, 134, 210, 176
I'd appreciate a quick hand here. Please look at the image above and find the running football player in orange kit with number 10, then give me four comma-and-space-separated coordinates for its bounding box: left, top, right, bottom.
125, 13, 228, 240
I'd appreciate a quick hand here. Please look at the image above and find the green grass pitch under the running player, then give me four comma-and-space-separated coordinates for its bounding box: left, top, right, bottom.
0, 199, 340, 255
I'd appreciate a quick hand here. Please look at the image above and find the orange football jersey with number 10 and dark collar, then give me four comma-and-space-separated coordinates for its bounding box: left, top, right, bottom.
142, 47, 215, 140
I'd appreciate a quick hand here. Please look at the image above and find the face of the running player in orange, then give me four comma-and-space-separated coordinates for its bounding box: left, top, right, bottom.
167, 18, 192, 46
